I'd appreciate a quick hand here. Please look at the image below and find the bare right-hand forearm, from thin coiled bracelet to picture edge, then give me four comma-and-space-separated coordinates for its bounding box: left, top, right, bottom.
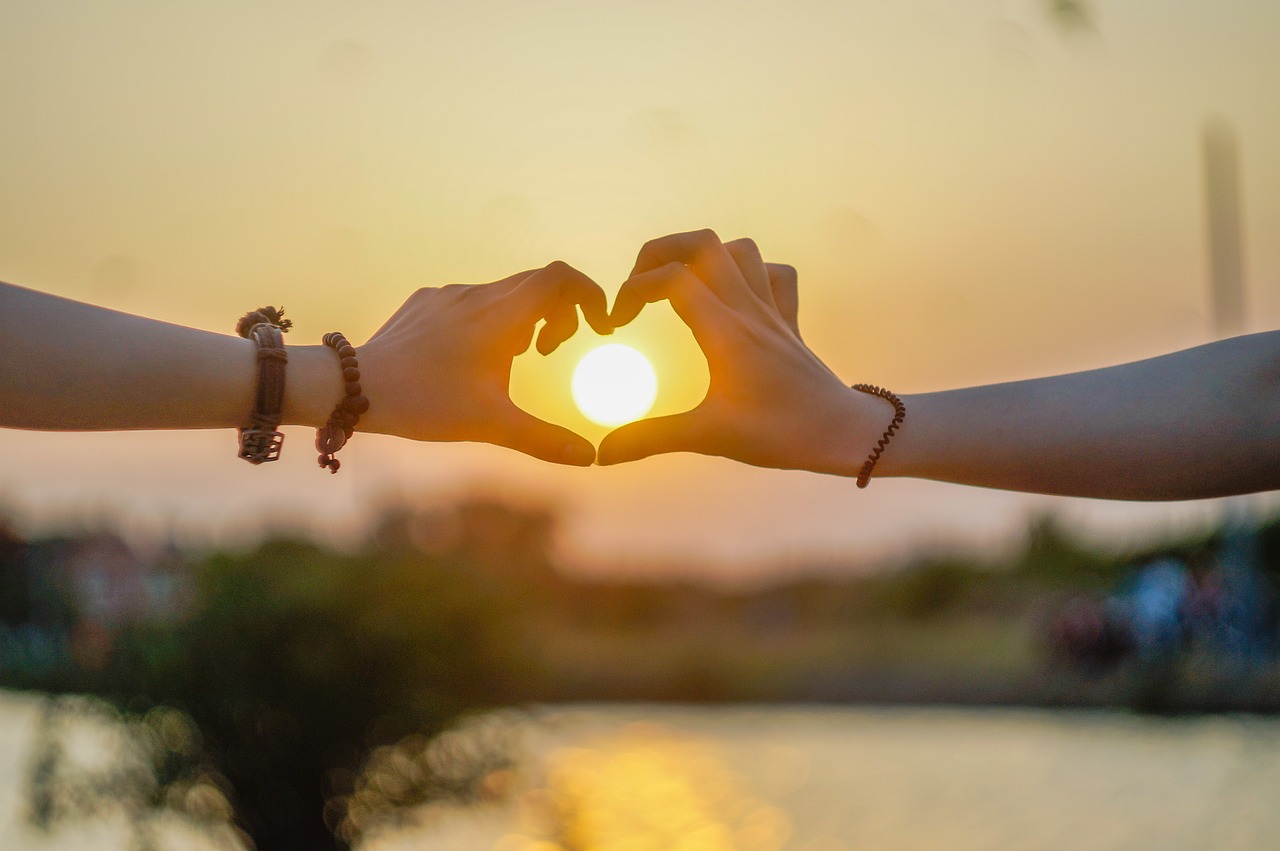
877, 333, 1280, 499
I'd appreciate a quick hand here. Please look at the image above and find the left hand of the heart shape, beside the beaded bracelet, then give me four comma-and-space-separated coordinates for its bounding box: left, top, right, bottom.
350, 261, 613, 466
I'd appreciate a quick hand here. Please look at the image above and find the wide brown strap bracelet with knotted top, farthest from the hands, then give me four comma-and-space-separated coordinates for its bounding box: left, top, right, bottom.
236, 307, 293, 465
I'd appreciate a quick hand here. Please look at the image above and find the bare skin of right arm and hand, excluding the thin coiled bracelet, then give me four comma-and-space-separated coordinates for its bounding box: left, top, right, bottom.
599, 230, 1280, 499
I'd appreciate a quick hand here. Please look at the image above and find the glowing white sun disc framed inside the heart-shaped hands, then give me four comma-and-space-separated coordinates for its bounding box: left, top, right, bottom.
573, 343, 658, 426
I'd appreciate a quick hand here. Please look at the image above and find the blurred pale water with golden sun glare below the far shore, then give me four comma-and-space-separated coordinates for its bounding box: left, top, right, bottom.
0, 696, 1280, 851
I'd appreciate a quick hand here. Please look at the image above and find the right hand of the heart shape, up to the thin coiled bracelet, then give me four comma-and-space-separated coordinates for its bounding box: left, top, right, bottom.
598, 230, 892, 475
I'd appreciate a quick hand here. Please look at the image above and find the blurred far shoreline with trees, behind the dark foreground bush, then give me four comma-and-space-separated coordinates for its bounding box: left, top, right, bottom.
0, 499, 1280, 713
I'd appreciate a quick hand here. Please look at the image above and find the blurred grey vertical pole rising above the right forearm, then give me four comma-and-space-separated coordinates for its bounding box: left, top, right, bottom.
1201, 118, 1244, 337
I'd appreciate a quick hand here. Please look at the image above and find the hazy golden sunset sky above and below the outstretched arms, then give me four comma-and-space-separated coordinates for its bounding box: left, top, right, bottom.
0, 0, 1280, 575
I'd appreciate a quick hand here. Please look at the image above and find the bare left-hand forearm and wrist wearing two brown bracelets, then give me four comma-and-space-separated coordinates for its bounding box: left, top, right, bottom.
0, 284, 342, 431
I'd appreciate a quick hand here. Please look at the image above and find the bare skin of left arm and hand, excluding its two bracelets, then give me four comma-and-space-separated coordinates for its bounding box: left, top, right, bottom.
0, 261, 612, 466
